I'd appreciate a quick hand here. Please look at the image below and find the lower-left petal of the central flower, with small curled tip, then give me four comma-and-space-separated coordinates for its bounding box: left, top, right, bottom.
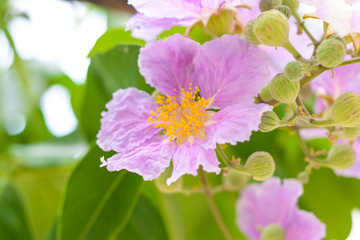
101, 136, 176, 181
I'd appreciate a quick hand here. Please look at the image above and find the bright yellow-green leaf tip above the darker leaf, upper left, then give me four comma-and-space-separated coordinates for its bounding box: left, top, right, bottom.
88, 28, 145, 57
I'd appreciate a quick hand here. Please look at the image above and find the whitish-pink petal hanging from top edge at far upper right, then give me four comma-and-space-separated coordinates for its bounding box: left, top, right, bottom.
316, 0, 352, 36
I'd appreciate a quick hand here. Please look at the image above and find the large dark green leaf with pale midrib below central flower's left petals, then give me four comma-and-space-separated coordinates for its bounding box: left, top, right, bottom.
59, 147, 142, 240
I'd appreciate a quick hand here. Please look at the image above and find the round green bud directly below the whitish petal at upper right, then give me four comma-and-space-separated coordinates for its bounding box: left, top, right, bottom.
316, 39, 346, 68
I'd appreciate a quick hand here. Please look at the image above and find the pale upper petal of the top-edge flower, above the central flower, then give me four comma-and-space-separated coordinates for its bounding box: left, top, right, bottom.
128, 0, 201, 19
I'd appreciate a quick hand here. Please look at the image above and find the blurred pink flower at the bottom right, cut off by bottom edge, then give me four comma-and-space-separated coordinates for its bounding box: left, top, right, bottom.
236, 177, 326, 240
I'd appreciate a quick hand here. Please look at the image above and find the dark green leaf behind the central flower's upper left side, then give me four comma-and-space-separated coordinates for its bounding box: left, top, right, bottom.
79, 46, 153, 142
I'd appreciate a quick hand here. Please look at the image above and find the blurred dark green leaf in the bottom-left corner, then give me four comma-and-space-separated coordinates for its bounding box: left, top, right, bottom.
0, 183, 34, 240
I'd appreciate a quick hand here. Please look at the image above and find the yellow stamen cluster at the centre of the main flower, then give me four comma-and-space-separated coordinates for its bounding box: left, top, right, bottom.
148, 84, 210, 141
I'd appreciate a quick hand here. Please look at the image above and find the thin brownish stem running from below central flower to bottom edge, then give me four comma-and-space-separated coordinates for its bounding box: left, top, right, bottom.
199, 168, 232, 240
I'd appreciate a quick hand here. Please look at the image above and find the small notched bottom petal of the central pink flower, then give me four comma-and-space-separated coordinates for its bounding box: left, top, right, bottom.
167, 139, 221, 185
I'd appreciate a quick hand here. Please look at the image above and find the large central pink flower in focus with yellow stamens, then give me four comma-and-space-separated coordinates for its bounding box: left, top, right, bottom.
97, 34, 272, 184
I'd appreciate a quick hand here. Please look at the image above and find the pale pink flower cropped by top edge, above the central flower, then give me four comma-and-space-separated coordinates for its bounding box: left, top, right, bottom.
126, 0, 260, 41
